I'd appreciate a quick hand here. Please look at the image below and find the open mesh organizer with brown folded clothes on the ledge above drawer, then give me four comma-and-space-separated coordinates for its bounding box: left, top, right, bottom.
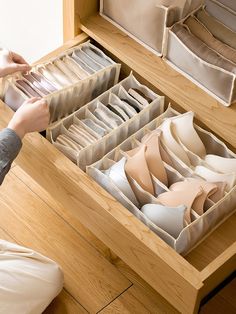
163, 0, 236, 106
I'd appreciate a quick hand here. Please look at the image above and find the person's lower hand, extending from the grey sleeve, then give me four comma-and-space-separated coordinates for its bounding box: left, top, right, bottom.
8, 97, 50, 139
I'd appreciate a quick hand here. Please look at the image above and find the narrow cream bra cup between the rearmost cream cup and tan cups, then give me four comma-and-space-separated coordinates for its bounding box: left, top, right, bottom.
160, 119, 190, 166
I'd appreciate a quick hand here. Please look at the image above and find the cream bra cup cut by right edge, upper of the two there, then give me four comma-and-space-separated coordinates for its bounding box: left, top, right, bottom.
204, 155, 236, 173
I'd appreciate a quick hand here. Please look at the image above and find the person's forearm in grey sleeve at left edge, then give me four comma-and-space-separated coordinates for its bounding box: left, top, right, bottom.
0, 128, 22, 185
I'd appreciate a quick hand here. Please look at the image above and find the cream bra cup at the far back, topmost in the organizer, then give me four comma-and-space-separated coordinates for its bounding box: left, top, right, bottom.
172, 112, 206, 158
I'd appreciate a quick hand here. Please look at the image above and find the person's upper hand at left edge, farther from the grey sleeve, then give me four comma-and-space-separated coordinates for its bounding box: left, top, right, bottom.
0, 49, 31, 77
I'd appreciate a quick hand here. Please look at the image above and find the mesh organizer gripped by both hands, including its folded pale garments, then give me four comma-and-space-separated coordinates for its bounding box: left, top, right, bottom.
4, 42, 120, 123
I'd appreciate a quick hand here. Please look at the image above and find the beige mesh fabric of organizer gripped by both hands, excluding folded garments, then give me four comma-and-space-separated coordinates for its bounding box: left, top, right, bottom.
3, 42, 120, 123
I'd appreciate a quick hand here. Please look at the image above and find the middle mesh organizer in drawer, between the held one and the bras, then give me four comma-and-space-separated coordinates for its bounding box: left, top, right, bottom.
47, 74, 164, 170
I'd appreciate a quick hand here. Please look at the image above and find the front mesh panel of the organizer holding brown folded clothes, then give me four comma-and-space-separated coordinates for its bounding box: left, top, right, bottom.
163, 4, 236, 106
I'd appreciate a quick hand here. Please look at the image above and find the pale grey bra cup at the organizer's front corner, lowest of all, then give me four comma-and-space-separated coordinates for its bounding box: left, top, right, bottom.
141, 204, 186, 238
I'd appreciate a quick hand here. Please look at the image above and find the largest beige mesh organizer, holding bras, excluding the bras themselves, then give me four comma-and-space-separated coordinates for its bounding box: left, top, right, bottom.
87, 107, 236, 254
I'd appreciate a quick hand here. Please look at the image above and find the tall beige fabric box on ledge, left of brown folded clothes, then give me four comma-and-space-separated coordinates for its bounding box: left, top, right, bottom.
100, 0, 203, 56
